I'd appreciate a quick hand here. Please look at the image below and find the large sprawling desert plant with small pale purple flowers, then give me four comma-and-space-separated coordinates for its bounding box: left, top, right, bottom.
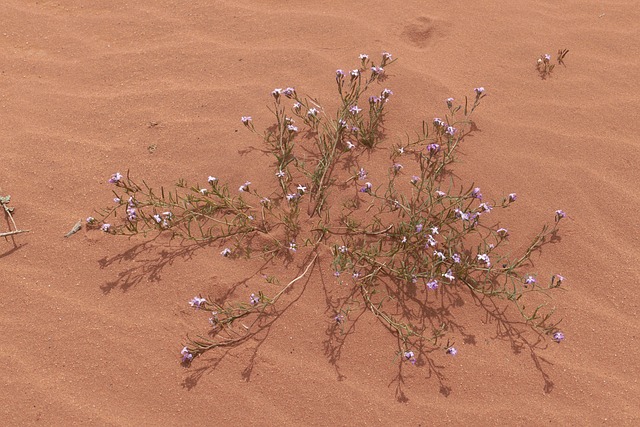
87, 51, 566, 372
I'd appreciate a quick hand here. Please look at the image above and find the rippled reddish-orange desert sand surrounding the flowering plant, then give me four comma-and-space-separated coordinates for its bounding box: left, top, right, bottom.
0, 0, 640, 426
